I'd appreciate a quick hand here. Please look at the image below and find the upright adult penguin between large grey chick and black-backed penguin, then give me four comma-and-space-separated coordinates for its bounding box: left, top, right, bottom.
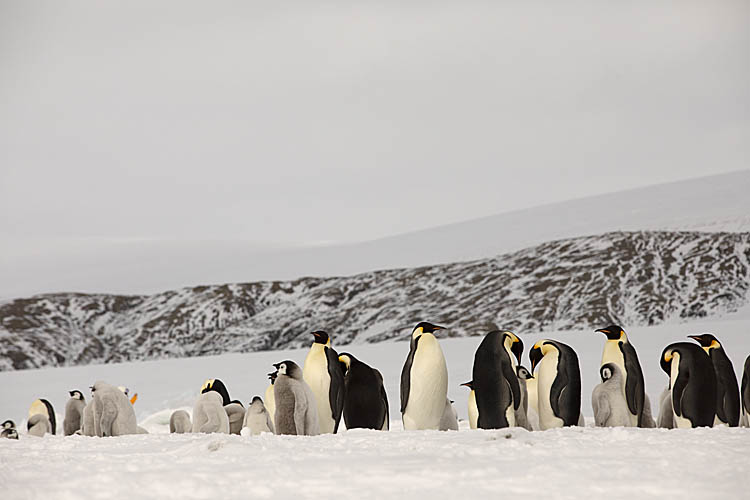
302, 331, 344, 434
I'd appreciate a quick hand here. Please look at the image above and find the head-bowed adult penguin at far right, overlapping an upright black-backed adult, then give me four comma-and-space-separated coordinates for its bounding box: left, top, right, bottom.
659, 342, 716, 429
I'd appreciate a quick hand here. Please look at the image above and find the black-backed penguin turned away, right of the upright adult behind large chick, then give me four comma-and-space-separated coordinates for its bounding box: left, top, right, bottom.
339, 352, 390, 431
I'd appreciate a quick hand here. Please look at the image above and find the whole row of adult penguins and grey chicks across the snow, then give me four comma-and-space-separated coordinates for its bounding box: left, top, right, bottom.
0, 322, 750, 439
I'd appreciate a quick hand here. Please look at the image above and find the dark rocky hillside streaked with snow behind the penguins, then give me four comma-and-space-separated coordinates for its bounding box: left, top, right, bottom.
0, 232, 750, 370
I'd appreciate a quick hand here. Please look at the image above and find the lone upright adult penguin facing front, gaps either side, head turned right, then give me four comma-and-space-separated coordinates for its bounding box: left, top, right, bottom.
401, 321, 448, 431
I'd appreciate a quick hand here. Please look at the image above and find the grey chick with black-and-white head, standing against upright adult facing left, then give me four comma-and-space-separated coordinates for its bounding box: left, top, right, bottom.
591, 363, 632, 427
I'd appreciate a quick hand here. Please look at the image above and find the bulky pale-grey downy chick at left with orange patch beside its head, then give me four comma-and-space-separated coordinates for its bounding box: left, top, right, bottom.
91, 381, 138, 437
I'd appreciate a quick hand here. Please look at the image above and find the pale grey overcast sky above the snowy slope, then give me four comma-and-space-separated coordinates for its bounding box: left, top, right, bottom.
0, 0, 750, 294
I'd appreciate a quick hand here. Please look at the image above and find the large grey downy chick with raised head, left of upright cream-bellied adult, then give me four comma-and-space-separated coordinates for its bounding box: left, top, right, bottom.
273, 360, 320, 436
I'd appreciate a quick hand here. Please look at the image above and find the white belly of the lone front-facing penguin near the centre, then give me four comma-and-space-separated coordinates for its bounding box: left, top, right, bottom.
403, 334, 448, 430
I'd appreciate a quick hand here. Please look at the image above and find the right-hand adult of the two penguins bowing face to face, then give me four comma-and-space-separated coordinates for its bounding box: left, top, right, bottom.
529, 339, 581, 430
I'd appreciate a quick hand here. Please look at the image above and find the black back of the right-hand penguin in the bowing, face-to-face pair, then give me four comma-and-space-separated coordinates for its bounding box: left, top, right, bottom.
545, 340, 581, 426
